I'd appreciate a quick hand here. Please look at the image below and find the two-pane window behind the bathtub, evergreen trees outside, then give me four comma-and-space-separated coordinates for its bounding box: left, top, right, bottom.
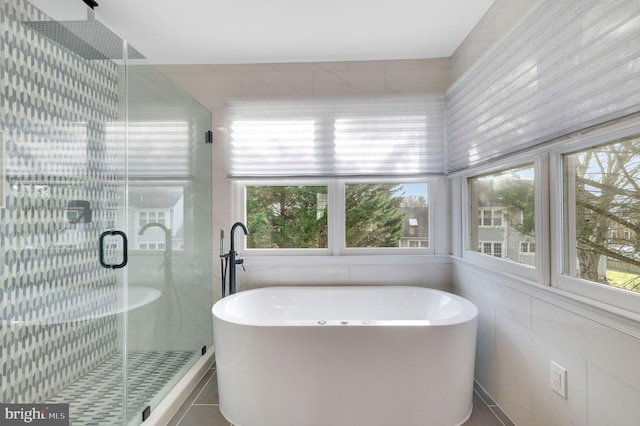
239, 179, 429, 254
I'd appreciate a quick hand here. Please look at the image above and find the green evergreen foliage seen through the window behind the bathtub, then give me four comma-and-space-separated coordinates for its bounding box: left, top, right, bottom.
246, 184, 404, 248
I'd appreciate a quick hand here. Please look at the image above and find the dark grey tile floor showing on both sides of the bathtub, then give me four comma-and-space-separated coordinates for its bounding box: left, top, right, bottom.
168, 366, 514, 426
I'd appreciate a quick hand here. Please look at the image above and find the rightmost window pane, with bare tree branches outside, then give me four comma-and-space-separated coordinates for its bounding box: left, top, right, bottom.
563, 135, 640, 293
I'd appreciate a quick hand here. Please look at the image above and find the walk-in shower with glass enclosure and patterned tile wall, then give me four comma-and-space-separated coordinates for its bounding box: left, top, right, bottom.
0, 0, 213, 425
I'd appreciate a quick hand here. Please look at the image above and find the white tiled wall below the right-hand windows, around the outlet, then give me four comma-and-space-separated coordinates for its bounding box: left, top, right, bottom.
452, 261, 640, 426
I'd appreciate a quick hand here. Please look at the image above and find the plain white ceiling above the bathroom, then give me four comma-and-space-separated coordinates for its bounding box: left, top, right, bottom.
32, 0, 494, 64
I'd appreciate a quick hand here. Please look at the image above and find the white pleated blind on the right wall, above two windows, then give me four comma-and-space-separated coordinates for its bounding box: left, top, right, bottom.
446, 0, 640, 171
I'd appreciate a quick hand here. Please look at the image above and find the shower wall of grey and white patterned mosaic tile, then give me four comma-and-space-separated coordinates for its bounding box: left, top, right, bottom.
0, 0, 118, 403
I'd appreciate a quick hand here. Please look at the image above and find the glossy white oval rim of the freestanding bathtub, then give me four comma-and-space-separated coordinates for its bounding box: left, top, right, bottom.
211, 285, 478, 327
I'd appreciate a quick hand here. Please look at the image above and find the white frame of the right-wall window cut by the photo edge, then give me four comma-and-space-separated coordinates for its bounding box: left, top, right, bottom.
549, 118, 640, 314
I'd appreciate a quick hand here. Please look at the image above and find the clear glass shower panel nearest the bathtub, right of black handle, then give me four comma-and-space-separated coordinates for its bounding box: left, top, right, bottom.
126, 65, 213, 420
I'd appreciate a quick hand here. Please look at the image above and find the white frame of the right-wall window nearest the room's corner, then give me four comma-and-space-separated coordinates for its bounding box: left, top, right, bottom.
460, 153, 549, 285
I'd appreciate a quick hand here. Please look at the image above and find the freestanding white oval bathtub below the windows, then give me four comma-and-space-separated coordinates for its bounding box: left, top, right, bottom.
213, 286, 478, 426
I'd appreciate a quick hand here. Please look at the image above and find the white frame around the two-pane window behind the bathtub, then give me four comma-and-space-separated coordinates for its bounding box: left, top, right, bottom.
231, 176, 446, 257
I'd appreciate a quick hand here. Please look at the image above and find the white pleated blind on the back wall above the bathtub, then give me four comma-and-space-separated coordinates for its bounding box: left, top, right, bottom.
227, 94, 444, 178
